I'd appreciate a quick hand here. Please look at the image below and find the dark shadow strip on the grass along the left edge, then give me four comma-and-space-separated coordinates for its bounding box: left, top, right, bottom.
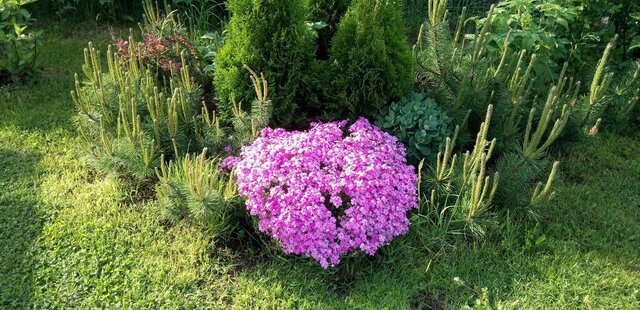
0, 148, 43, 309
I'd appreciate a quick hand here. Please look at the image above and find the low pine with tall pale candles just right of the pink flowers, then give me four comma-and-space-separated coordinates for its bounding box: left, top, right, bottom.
411, 105, 559, 239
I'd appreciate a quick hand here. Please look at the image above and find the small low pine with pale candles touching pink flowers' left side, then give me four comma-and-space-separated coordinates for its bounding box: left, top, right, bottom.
156, 149, 242, 236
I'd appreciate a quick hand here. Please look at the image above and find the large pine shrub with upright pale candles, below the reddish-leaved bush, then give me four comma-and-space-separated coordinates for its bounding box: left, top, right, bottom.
72, 43, 205, 180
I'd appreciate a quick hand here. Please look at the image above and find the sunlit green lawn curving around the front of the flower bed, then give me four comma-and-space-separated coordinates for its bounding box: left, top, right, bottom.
0, 24, 640, 309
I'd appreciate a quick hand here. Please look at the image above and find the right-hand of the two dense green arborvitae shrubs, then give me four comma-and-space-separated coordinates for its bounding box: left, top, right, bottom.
331, 0, 414, 116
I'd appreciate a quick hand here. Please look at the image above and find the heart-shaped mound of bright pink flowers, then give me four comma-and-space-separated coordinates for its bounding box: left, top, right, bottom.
233, 119, 417, 268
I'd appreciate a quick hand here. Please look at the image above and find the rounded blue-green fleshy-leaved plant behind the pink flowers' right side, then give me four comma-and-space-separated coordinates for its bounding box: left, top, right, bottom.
376, 93, 453, 163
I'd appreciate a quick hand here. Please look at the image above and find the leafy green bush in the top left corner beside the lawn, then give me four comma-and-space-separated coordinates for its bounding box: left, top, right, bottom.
0, 0, 42, 82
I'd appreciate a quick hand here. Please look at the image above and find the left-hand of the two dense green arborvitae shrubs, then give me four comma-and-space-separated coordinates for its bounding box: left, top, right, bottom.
215, 0, 313, 125
